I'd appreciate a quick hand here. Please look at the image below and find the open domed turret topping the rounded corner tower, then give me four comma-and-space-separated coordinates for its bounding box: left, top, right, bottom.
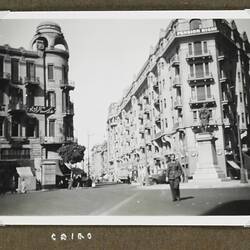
31, 22, 68, 52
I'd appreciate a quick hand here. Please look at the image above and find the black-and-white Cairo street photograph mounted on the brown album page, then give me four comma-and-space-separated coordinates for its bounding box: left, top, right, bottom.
0, 13, 250, 224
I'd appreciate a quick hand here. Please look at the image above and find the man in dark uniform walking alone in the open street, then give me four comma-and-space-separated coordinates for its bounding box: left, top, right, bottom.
166, 154, 183, 201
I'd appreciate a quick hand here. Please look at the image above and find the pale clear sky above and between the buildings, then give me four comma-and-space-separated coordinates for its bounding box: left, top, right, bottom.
0, 15, 250, 155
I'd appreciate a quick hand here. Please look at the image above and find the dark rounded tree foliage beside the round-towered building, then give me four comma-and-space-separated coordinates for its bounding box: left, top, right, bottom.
58, 143, 86, 164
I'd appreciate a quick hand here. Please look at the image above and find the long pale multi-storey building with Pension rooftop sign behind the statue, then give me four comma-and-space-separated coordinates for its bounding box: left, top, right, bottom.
108, 19, 250, 184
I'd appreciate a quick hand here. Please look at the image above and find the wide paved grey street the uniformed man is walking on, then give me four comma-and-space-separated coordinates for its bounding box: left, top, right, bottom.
0, 184, 250, 215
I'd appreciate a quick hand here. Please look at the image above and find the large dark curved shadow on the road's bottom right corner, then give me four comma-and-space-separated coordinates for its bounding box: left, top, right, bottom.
203, 200, 250, 215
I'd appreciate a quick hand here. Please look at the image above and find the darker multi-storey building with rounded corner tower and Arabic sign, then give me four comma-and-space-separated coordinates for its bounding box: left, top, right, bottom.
0, 22, 74, 188
